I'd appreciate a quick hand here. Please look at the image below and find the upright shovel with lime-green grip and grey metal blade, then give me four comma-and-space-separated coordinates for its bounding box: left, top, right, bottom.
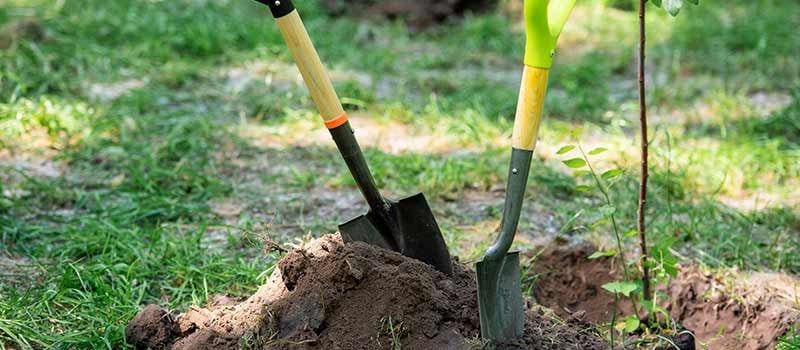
476, 0, 576, 348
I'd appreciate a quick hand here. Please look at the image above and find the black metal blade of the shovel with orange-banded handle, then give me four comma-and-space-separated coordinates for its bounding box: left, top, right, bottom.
339, 193, 453, 275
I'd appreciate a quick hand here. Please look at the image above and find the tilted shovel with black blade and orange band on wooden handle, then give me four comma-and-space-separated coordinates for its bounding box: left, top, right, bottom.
256, 0, 452, 275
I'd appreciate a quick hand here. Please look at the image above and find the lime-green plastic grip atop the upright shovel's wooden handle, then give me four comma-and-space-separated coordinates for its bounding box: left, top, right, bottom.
525, 0, 577, 69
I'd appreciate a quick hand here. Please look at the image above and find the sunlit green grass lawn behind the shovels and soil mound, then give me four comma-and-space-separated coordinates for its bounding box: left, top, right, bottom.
0, 0, 800, 348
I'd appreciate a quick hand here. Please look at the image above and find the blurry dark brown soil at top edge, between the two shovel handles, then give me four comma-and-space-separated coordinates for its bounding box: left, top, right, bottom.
322, 0, 496, 29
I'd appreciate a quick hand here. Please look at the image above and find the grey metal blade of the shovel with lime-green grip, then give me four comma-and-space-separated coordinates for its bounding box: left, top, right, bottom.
476, 252, 525, 342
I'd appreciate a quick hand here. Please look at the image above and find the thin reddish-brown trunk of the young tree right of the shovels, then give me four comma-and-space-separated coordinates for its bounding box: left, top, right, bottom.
636, 0, 650, 300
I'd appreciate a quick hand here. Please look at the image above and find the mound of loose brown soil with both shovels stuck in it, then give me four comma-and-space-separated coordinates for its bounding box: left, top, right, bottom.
126, 235, 606, 349
